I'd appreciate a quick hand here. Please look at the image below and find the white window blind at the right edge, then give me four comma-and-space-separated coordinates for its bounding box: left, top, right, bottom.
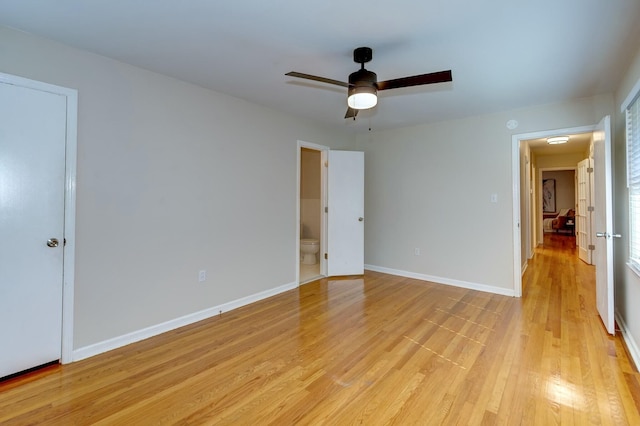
626, 97, 640, 272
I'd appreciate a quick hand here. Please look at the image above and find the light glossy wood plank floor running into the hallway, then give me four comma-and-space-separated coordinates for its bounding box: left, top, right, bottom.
0, 235, 640, 425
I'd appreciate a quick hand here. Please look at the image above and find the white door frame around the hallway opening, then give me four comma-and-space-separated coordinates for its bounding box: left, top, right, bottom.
511, 124, 597, 297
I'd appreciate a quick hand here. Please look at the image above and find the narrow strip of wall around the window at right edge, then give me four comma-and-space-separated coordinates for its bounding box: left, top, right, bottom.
612, 40, 640, 365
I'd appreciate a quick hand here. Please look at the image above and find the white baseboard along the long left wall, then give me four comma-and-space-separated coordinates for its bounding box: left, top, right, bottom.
72, 282, 298, 361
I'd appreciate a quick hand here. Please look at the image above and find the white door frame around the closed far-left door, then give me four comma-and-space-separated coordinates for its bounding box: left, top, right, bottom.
0, 73, 78, 364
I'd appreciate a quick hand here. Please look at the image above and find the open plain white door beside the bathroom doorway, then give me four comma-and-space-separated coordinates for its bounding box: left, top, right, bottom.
327, 151, 364, 276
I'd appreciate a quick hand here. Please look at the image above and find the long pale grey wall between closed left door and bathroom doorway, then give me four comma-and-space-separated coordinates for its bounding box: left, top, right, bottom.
0, 27, 354, 349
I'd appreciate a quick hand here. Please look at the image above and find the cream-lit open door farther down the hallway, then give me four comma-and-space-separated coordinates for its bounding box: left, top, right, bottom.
576, 158, 593, 264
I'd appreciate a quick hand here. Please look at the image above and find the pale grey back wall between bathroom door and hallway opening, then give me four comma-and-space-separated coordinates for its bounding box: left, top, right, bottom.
358, 95, 613, 294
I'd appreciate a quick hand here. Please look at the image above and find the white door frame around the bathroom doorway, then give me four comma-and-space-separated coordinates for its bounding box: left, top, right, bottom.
295, 140, 330, 286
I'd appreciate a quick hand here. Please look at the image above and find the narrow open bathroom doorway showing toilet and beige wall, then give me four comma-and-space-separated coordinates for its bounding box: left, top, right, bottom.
296, 141, 329, 284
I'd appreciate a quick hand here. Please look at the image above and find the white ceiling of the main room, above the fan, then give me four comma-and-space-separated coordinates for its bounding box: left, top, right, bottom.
0, 0, 640, 130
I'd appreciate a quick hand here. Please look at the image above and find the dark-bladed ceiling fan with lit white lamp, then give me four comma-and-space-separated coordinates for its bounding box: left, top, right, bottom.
285, 47, 453, 120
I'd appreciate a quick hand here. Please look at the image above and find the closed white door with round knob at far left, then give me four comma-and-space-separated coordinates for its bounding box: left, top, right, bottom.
0, 82, 66, 377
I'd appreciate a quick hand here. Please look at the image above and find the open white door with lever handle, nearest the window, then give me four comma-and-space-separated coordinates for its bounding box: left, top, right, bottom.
593, 116, 616, 334
